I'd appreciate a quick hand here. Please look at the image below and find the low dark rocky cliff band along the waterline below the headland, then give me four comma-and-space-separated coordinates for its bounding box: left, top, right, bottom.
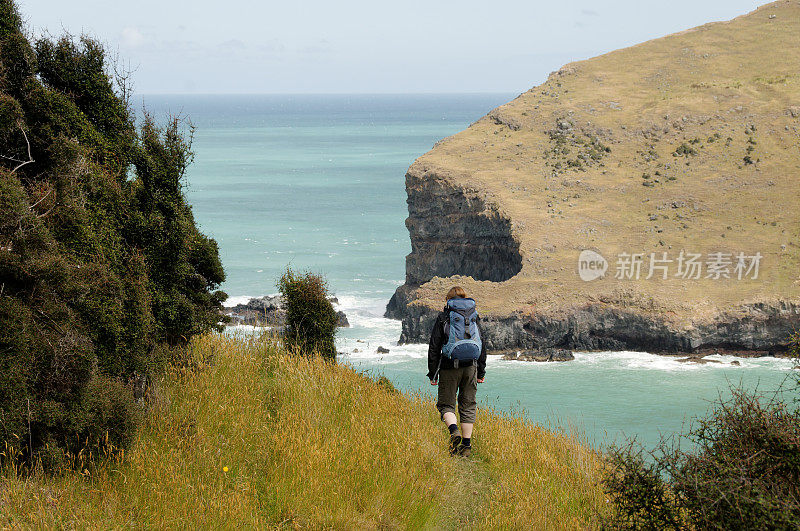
386, 286, 800, 361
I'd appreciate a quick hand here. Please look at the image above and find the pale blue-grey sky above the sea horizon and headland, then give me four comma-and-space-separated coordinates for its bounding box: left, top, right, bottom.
18, 0, 763, 94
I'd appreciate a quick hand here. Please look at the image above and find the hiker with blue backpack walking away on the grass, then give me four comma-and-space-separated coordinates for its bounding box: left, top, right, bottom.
428, 286, 486, 457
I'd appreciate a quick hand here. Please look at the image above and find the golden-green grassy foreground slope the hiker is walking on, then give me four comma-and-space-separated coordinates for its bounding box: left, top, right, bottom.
0, 334, 605, 529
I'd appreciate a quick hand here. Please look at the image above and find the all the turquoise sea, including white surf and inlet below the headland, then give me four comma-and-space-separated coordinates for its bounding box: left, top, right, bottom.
144, 94, 792, 444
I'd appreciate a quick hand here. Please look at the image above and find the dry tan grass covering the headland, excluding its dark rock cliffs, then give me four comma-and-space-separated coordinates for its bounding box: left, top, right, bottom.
409, 0, 800, 323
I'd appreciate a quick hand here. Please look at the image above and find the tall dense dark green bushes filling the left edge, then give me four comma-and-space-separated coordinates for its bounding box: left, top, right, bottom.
0, 0, 225, 470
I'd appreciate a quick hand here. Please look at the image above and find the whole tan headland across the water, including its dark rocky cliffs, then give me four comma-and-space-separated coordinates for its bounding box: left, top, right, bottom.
387, 0, 800, 358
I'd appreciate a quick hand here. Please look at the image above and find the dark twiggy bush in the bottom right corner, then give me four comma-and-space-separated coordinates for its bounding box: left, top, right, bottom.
603, 389, 800, 529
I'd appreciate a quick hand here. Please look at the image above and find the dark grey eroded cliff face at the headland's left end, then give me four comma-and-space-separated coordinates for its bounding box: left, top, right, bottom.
406, 166, 522, 286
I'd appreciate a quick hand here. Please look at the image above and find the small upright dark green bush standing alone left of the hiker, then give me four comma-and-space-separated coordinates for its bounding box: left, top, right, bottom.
278, 269, 337, 358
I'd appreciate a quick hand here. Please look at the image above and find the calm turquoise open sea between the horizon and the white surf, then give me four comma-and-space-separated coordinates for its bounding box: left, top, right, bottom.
138, 94, 490, 302
